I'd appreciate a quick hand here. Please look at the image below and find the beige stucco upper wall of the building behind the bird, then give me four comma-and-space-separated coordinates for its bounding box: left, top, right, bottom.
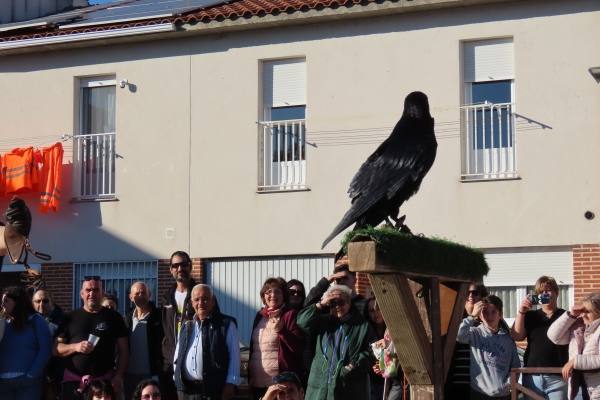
0, 1, 600, 260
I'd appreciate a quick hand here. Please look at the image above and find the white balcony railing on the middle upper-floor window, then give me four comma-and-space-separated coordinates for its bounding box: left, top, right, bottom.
258, 119, 306, 191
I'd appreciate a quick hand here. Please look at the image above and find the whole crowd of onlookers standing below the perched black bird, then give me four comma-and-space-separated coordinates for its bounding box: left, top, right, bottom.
0, 251, 600, 400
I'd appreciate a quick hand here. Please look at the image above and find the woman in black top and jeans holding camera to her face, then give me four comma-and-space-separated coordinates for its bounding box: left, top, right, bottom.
511, 276, 569, 400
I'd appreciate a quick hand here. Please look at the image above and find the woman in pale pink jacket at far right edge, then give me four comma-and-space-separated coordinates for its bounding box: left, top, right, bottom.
548, 293, 600, 400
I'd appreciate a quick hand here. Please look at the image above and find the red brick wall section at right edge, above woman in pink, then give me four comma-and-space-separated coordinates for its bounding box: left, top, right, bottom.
573, 244, 600, 303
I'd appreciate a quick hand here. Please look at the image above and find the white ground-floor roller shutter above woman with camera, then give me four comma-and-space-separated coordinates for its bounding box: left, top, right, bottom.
484, 248, 573, 286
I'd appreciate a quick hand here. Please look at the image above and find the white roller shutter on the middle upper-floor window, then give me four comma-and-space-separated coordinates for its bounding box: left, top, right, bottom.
263, 59, 306, 107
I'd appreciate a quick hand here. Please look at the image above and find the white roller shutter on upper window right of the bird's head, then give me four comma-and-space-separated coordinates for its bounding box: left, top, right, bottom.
464, 39, 514, 82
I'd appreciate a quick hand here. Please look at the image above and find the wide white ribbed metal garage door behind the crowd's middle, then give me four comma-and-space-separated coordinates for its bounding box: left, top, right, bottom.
206, 256, 333, 344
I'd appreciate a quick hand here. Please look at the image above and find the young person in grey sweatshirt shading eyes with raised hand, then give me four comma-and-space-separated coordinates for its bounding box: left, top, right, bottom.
457, 295, 521, 400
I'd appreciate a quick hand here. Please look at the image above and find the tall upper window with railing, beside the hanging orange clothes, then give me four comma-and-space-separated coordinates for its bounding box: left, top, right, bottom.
73, 77, 116, 199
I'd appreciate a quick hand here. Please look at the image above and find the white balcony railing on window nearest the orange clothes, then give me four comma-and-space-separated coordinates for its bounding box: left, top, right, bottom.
73, 132, 116, 200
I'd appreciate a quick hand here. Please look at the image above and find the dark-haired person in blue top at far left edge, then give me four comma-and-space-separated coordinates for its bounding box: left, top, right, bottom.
0, 286, 52, 400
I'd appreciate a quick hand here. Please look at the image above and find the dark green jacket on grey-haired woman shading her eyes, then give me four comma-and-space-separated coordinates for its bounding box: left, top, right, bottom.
297, 305, 375, 400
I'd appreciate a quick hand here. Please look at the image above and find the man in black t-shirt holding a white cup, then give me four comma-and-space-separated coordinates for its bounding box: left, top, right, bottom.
55, 276, 129, 400
